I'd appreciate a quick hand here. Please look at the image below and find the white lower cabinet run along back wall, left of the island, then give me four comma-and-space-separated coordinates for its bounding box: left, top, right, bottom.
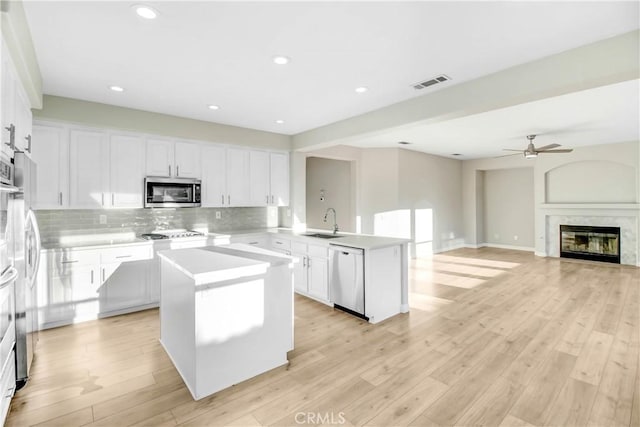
38, 245, 153, 329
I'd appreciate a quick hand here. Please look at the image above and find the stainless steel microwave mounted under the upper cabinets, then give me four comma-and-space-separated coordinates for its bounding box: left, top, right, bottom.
144, 176, 201, 208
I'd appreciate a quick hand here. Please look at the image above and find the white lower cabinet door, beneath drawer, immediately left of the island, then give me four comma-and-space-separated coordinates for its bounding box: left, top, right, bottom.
100, 261, 150, 313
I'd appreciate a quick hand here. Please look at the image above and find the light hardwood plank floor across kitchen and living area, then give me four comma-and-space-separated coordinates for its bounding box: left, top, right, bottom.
7, 248, 640, 426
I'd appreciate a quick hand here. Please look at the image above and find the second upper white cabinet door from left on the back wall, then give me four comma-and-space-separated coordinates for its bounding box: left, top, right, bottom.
69, 129, 109, 209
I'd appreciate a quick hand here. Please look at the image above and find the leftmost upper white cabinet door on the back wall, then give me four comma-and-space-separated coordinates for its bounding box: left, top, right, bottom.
31, 125, 69, 209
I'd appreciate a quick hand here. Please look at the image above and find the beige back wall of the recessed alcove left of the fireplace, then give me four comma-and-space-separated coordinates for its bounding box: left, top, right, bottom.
481, 167, 535, 250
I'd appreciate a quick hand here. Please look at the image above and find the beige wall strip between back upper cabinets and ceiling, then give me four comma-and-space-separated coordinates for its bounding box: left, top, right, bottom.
33, 95, 291, 150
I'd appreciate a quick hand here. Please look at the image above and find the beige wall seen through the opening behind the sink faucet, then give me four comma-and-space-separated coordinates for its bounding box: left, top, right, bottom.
306, 157, 355, 232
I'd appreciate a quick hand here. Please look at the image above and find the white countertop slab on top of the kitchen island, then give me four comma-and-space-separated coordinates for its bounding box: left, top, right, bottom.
158, 244, 290, 285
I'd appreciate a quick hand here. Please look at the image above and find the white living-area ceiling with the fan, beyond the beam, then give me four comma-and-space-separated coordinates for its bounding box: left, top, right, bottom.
348, 80, 640, 160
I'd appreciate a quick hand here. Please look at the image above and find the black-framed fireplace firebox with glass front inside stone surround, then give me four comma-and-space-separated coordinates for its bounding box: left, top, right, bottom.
560, 225, 620, 264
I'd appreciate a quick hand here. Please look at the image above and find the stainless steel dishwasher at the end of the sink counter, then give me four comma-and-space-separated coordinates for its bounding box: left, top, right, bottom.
329, 244, 369, 320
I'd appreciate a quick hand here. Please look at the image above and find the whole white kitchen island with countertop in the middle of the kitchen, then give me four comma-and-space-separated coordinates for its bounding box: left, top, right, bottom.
159, 244, 293, 400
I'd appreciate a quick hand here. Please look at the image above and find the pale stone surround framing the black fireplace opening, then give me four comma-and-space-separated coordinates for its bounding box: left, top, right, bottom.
545, 209, 640, 266
